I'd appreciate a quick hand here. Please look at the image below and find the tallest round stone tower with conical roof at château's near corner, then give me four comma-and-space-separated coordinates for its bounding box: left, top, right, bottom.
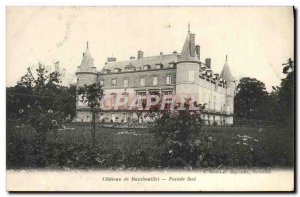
176, 28, 200, 106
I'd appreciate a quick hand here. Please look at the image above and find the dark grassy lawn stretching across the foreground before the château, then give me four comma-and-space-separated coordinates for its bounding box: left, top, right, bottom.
7, 123, 294, 169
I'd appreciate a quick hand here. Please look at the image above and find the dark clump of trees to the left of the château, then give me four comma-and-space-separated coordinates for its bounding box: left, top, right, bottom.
6, 63, 76, 119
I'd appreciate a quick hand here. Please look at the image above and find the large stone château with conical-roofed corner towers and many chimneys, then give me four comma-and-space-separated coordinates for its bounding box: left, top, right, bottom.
76, 26, 235, 125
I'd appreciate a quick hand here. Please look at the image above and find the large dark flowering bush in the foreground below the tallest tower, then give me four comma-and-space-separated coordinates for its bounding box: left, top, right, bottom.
152, 110, 213, 168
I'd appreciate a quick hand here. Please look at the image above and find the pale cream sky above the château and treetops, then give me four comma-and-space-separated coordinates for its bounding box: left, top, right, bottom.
6, 7, 294, 90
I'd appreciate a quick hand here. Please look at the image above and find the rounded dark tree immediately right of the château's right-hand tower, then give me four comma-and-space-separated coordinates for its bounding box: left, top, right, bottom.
234, 77, 268, 119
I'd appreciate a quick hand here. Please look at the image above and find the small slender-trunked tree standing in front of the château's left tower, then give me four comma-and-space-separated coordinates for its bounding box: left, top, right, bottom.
77, 82, 103, 146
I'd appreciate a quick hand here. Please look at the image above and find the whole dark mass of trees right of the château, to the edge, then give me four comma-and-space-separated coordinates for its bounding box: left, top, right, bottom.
234, 58, 295, 126
